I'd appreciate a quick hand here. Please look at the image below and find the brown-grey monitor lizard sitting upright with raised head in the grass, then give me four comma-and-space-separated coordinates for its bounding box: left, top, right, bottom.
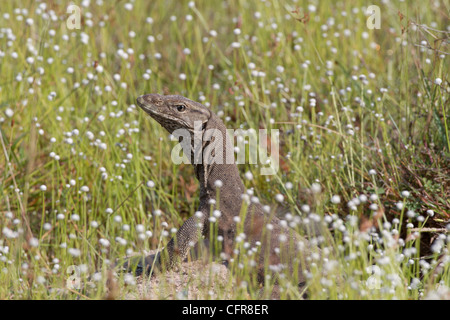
126, 94, 310, 296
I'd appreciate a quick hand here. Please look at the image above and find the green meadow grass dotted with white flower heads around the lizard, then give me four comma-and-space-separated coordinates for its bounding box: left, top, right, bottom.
0, 0, 450, 299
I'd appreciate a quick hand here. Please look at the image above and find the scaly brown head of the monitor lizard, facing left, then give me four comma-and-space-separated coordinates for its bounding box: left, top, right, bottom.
136, 94, 211, 133
